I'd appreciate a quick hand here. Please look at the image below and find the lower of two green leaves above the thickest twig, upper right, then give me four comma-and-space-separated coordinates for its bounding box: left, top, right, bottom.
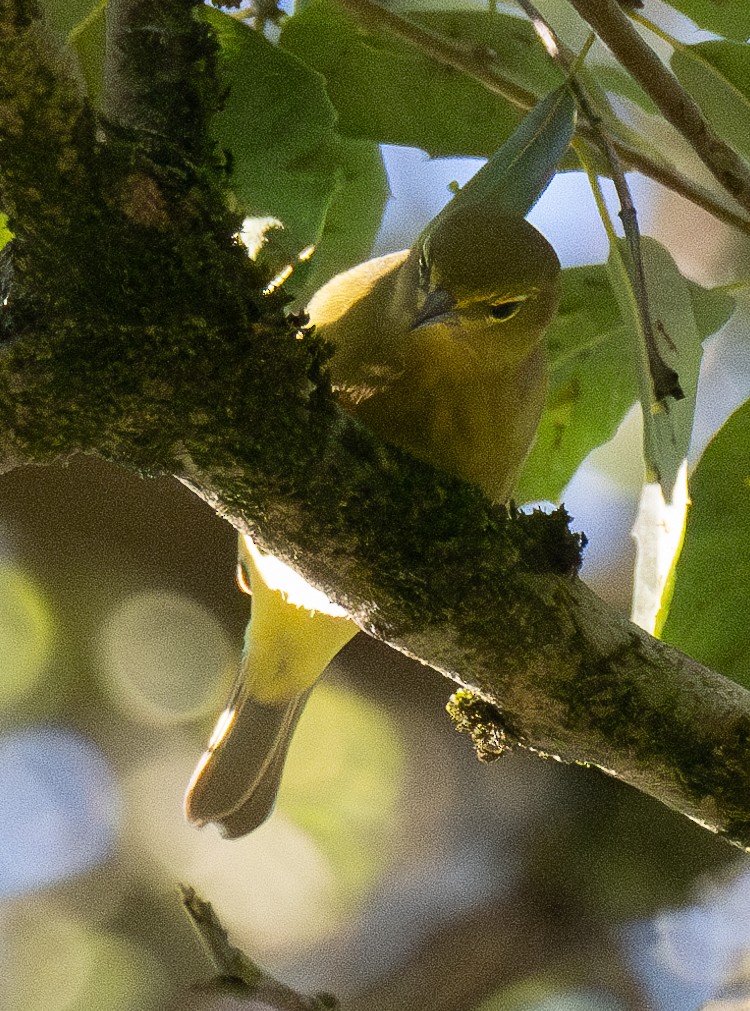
671, 41, 750, 159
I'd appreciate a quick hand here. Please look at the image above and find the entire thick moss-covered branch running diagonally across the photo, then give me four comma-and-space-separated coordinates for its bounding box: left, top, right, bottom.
0, 0, 750, 847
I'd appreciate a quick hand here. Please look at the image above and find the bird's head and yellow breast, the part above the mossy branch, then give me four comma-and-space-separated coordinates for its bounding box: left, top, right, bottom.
307, 205, 560, 501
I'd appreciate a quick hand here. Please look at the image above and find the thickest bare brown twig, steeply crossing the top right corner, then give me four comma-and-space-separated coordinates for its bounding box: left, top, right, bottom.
570, 0, 750, 218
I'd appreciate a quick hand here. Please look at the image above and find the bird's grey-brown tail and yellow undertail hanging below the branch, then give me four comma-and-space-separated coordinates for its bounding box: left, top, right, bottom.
185, 535, 357, 838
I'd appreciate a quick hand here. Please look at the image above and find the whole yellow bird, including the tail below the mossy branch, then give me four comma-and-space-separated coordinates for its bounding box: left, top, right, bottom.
185, 205, 560, 837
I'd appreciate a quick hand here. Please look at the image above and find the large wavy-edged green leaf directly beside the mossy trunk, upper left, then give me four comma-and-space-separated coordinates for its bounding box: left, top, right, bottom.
207, 8, 340, 251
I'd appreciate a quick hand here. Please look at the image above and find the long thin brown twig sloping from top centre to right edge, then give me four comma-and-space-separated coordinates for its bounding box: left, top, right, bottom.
339, 0, 750, 235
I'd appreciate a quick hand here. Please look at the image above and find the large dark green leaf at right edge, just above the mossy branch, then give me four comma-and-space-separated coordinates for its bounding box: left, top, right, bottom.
662, 394, 750, 687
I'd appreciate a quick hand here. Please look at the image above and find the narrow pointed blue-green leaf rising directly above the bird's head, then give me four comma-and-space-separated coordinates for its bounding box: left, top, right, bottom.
426, 86, 576, 233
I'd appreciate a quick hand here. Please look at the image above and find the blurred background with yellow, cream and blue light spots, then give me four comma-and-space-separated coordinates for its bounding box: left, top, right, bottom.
0, 3, 750, 1011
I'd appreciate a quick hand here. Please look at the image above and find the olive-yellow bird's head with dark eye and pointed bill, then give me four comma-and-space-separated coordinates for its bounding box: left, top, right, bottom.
404, 207, 560, 360
